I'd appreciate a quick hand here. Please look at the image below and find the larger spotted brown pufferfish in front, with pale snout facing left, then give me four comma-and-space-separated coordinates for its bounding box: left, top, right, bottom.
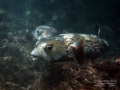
31, 33, 109, 64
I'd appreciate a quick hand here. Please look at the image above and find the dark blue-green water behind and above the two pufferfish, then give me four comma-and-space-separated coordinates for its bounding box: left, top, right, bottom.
0, 0, 120, 37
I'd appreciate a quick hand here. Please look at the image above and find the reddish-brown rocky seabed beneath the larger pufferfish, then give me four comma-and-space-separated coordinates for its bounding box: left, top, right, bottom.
27, 57, 120, 90
